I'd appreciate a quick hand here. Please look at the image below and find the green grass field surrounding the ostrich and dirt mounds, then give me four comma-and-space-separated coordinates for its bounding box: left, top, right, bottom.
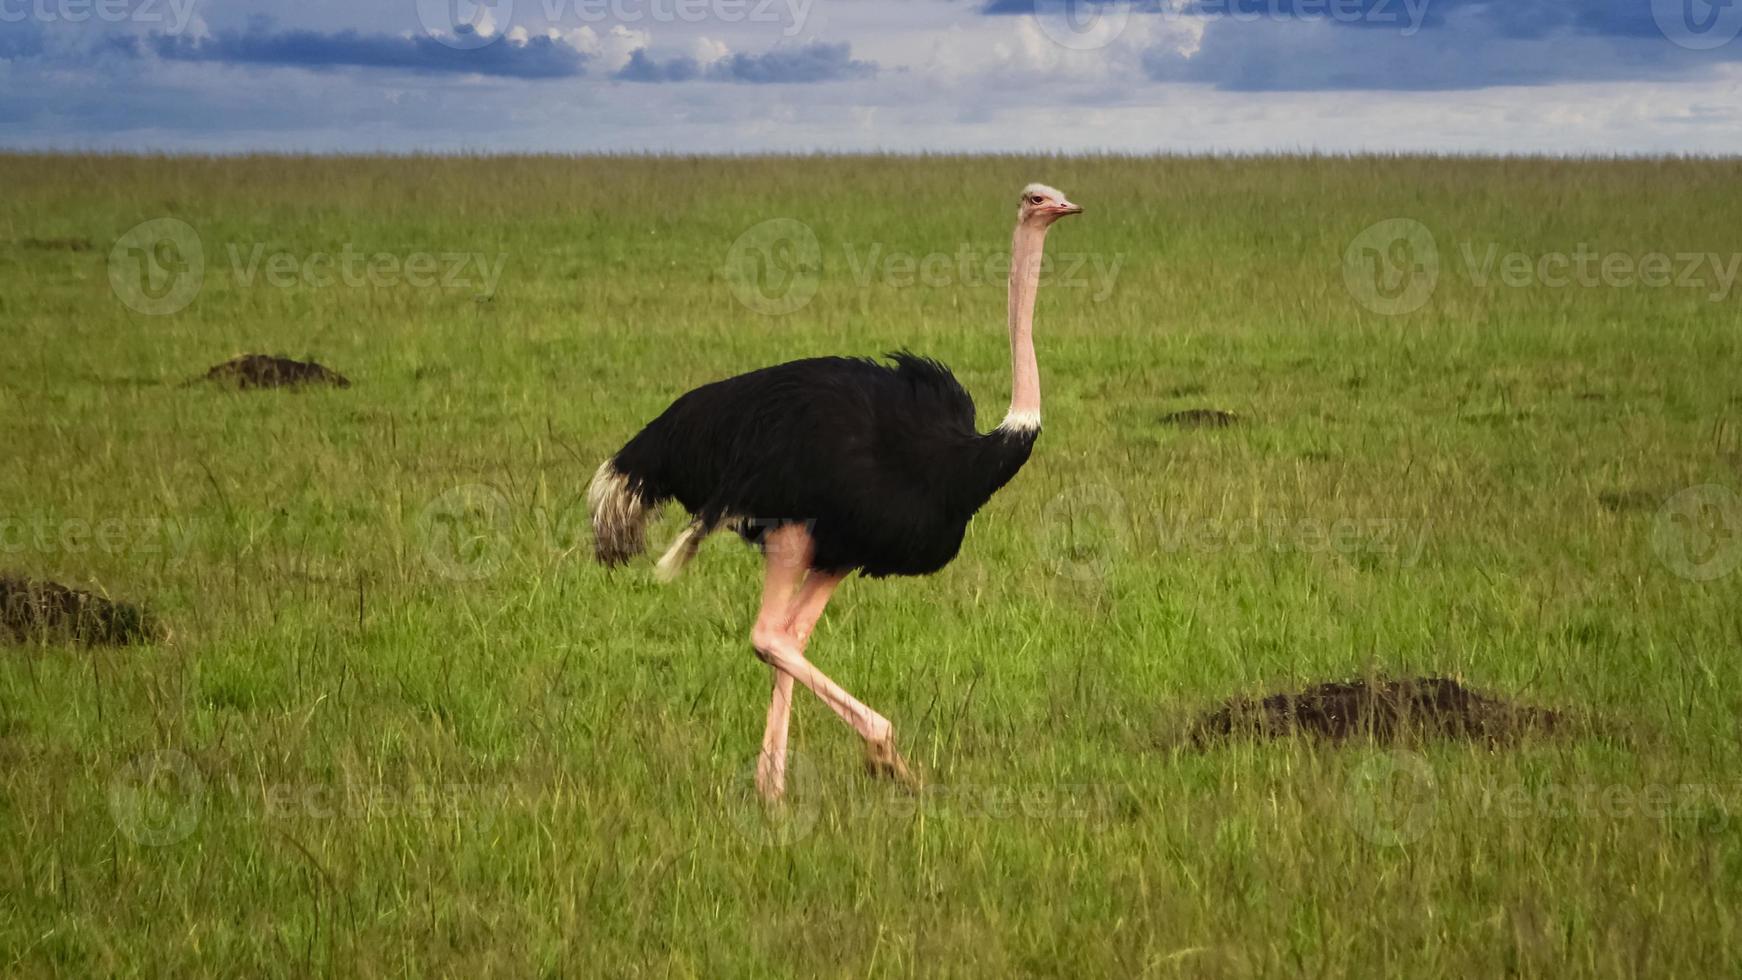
0, 157, 1742, 977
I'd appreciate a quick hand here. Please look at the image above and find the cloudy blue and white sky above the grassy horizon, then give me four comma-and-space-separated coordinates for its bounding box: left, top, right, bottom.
0, 0, 1742, 153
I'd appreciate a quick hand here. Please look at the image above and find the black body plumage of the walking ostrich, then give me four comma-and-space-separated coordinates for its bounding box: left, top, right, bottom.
599, 352, 1038, 576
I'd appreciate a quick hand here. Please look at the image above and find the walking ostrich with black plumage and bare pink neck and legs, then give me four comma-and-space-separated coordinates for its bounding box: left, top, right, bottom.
587, 185, 1082, 801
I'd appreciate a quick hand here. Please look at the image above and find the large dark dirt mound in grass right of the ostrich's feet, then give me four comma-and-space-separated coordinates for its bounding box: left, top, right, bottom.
1192, 677, 1566, 748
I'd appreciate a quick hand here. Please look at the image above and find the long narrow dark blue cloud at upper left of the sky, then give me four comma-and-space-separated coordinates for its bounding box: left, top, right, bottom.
111, 30, 587, 78
